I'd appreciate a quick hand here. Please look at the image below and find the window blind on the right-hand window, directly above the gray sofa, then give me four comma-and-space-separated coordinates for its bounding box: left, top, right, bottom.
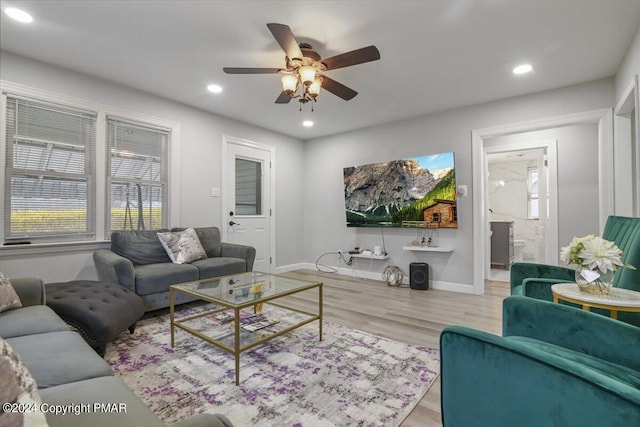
106, 117, 171, 235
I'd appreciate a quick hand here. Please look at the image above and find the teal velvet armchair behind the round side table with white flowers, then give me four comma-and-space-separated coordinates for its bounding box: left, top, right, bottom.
510, 216, 640, 326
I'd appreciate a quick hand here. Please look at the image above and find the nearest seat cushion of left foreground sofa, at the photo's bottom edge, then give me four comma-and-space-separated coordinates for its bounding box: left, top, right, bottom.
40, 377, 165, 427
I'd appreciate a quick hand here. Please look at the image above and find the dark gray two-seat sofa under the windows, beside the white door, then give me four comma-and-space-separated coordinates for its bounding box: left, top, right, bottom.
93, 227, 256, 311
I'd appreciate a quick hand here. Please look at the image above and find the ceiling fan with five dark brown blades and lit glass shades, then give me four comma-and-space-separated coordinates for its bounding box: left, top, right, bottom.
222, 24, 380, 111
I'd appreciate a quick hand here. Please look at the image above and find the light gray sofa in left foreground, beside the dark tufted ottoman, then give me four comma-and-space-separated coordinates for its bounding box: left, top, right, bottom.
0, 278, 232, 427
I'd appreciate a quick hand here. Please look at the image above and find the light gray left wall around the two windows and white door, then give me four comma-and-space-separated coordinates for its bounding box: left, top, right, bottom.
0, 52, 304, 282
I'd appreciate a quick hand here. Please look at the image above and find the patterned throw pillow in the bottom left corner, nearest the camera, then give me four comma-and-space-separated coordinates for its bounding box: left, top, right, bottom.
0, 338, 48, 427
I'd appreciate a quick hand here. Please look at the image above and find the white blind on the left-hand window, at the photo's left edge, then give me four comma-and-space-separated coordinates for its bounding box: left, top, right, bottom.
4, 95, 96, 240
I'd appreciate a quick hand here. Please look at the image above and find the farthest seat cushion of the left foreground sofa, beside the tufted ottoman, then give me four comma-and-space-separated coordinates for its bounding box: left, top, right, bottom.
0, 305, 69, 338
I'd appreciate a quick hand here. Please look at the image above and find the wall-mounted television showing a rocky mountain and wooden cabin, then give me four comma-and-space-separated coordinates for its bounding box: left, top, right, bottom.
343, 152, 458, 228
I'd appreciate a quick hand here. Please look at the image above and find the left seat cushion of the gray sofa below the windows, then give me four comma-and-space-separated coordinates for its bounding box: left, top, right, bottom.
134, 262, 199, 295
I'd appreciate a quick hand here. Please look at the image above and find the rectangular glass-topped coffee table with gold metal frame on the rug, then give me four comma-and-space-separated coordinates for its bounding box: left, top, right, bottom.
169, 272, 322, 385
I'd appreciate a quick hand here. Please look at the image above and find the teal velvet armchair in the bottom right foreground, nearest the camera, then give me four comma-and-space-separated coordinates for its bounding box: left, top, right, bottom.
440, 296, 640, 427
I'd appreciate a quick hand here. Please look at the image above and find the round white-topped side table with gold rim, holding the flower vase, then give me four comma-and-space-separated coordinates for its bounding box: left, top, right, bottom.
551, 283, 640, 319
